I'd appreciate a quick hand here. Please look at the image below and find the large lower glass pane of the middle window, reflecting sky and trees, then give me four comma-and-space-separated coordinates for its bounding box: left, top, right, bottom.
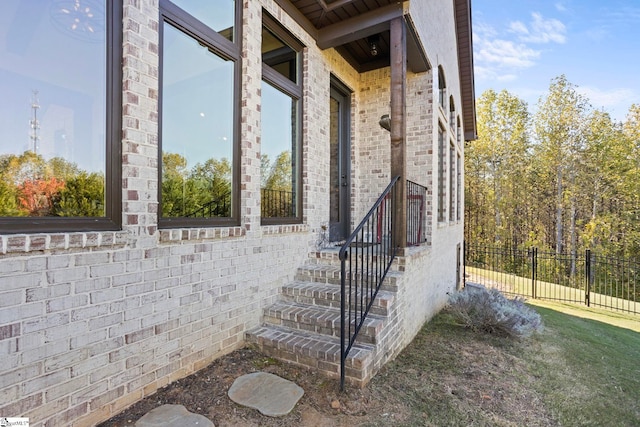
161, 23, 234, 218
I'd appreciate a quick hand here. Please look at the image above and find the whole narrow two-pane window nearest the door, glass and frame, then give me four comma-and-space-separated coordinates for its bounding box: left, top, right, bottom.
260, 14, 302, 224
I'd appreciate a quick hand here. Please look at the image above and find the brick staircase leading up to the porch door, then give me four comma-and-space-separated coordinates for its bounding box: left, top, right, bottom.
246, 249, 402, 387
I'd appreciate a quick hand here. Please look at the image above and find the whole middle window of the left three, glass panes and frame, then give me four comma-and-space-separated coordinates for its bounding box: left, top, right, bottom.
159, 0, 239, 227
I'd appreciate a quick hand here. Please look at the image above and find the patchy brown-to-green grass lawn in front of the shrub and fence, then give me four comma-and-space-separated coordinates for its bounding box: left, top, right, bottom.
364, 301, 640, 426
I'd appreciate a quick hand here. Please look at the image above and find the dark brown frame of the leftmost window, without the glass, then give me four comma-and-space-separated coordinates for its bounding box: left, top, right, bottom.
0, 0, 123, 234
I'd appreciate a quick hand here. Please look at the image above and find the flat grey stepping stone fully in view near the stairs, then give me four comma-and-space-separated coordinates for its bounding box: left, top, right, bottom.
227, 372, 304, 417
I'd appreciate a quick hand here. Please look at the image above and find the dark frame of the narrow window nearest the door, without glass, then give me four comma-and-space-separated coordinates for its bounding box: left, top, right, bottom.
260, 10, 304, 225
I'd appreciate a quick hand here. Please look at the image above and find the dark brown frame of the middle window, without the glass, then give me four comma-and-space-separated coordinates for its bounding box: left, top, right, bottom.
158, 0, 242, 229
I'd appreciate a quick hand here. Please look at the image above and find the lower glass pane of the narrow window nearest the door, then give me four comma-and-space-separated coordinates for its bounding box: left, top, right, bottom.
261, 81, 298, 218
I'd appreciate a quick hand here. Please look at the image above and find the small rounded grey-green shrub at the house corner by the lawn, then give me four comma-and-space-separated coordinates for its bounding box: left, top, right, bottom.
447, 286, 543, 338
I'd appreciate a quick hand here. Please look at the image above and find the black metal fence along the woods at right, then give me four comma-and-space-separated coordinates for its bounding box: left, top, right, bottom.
464, 243, 640, 314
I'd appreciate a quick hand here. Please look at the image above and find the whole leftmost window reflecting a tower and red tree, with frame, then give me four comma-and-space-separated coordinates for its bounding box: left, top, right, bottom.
0, 0, 122, 233
